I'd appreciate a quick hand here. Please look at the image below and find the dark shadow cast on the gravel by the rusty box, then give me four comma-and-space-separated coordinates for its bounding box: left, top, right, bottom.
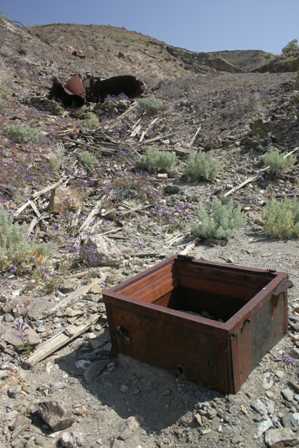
56, 334, 220, 432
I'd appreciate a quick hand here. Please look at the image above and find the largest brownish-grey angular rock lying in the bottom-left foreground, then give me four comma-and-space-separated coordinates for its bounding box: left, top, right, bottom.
37, 401, 74, 432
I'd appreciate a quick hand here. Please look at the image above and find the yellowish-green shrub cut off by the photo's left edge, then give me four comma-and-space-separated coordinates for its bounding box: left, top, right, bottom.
0, 207, 50, 271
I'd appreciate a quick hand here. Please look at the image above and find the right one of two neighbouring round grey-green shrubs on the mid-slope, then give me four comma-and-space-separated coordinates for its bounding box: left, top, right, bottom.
184, 152, 220, 182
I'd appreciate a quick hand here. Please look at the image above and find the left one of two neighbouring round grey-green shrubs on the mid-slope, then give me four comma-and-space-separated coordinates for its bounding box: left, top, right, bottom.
137, 149, 177, 173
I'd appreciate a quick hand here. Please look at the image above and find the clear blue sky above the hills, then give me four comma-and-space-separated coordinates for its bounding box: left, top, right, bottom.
0, 0, 299, 53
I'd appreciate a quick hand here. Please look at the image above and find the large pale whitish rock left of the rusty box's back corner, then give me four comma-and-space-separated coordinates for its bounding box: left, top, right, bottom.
80, 235, 121, 267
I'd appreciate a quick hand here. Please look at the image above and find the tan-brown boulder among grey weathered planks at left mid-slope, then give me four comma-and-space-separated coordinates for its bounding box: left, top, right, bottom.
49, 186, 82, 214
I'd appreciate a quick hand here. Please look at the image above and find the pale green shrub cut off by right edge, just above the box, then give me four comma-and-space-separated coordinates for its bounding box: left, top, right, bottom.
263, 199, 299, 239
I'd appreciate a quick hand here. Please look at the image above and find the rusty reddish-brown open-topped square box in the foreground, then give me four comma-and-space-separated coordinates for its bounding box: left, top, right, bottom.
104, 256, 290, 393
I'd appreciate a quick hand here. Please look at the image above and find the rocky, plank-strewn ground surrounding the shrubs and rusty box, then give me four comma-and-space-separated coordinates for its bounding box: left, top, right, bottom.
0, 15, 299, 448
